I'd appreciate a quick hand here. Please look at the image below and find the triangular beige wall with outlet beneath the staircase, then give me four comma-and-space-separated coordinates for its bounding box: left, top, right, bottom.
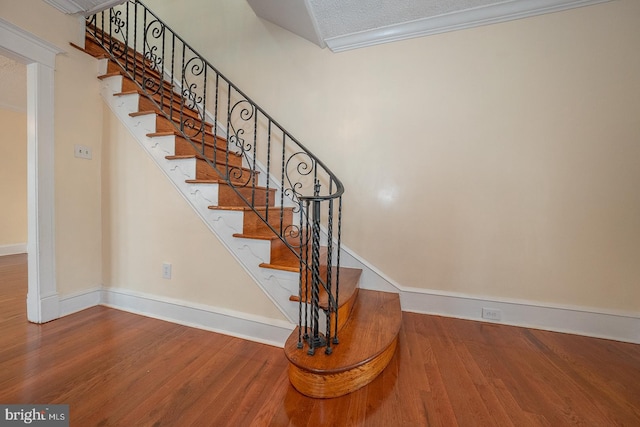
102, 105, 284, 320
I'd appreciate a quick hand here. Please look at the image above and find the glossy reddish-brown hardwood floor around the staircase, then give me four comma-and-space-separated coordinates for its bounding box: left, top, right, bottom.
0, 255, 640, 427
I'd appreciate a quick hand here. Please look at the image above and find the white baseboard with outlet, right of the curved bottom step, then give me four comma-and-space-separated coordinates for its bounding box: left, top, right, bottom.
400, 288, 640, 344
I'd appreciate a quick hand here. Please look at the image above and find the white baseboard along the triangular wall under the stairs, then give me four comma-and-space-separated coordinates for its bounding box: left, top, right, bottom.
101, 288, 295, 347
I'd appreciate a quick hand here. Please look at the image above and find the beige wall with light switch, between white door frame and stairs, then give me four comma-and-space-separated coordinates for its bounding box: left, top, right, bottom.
0, 0, 102, 296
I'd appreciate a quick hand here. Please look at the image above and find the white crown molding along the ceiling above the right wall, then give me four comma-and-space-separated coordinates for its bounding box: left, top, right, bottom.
324, 0, 611, 52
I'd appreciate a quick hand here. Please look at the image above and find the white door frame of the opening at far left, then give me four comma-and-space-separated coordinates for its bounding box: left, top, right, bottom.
0, 18, 64, 323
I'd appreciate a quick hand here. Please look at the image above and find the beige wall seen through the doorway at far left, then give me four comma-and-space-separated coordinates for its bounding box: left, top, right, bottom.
0, 108, 27, 246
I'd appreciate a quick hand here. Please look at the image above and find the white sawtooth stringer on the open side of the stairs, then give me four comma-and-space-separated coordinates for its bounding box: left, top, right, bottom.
100, 70, 300, 329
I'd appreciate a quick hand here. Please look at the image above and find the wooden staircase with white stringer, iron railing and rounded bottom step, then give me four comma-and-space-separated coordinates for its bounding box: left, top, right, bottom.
75, 1, 402, 398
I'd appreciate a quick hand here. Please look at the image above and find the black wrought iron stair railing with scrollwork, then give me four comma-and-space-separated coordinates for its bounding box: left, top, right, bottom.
87, 0, 344, 354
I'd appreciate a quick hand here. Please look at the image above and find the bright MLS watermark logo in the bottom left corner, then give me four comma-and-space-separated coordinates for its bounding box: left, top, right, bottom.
0, 405, 69, 427
